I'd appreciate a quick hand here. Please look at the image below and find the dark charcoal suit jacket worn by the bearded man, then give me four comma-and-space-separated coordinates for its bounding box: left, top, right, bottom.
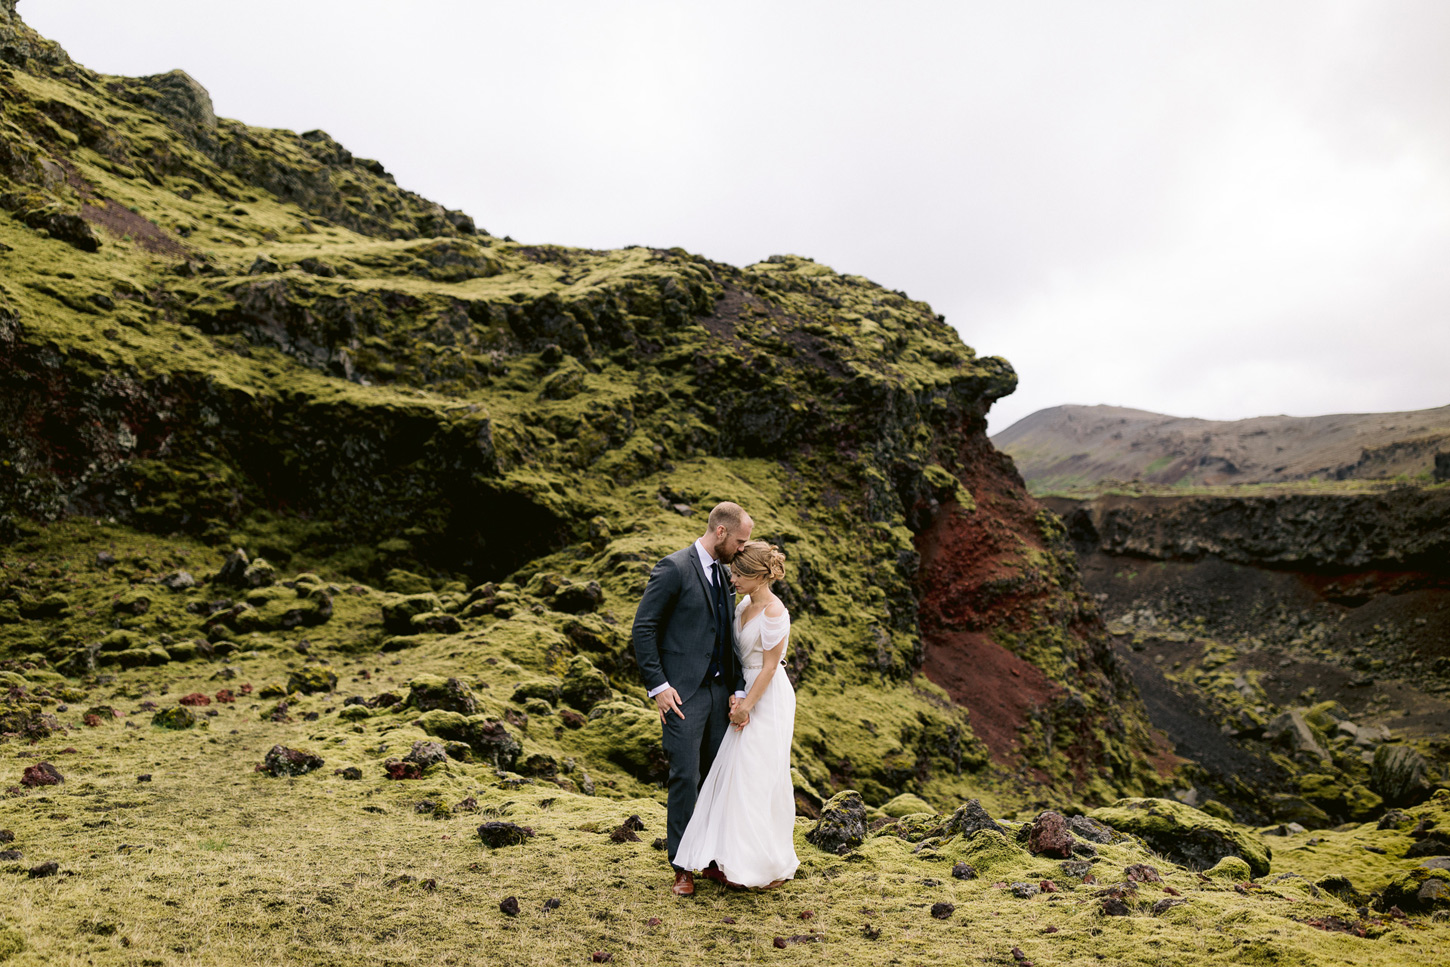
632, 544, 745, 702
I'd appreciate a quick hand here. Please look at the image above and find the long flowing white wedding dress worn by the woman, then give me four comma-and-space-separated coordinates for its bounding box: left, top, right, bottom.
674, 596, 800, 886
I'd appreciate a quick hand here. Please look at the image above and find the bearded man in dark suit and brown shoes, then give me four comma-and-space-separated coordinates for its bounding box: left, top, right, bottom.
634, 502, 754, 896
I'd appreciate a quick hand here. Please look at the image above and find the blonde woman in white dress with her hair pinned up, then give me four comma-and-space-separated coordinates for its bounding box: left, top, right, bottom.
674, 541, 799, 887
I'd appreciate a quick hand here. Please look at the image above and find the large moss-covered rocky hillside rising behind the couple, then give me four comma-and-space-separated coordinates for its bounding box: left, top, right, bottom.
0, 0, 1140, 823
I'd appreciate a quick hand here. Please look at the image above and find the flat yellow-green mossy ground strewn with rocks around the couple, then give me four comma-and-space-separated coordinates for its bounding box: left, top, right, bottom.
0, 525, 1450, 967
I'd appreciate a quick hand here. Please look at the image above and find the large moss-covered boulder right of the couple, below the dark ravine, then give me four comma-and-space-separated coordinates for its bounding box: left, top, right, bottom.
1089, 799, 1272, 876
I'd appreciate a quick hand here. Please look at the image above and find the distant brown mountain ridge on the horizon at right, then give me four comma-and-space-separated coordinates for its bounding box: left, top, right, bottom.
992, 406, 1450, 491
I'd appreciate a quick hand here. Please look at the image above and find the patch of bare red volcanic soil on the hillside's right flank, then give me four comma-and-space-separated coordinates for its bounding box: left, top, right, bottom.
916, 435, 1063, 764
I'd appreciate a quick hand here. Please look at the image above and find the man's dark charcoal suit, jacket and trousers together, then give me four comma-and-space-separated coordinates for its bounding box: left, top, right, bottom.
634, 544, 745, 863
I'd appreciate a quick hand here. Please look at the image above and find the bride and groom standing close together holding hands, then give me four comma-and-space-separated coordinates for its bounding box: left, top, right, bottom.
634, 502, 799, 896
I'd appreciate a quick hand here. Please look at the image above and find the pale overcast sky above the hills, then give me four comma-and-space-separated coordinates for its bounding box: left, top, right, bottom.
19, 0, 1450, 432
